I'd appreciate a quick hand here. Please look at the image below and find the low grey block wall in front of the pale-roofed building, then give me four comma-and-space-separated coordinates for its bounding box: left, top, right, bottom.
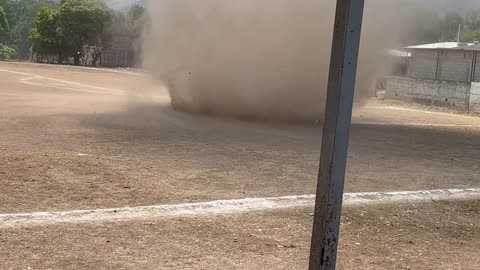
385, 77, 470, 109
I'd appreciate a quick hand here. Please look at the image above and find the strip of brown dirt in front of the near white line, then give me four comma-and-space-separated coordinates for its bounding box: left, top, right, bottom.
0, 201, 480, 270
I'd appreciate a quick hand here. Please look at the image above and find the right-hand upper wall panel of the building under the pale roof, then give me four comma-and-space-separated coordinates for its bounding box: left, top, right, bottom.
437, 50, 474, 82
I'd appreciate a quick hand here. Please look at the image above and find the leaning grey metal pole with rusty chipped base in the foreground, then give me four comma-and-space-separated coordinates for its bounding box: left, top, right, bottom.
309, 0, 364, 270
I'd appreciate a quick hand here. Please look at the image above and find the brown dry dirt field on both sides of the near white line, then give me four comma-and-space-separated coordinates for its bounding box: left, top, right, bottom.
0, 62, 480, 269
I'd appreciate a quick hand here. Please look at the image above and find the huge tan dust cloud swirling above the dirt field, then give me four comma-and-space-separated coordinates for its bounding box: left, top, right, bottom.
143, 0, 401, 121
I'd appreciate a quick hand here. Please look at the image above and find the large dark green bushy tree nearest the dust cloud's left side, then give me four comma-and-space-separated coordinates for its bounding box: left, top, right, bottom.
28, 0, 143, 66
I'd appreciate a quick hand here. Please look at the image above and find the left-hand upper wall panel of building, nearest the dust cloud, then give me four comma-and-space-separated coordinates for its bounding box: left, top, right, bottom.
407, 50, 438, 80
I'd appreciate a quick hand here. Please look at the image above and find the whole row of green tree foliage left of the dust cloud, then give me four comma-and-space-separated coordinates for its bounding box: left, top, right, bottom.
0, 0, 143, 65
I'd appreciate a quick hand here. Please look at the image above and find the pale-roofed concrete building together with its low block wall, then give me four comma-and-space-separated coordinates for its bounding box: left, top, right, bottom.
385, 42, 480, 113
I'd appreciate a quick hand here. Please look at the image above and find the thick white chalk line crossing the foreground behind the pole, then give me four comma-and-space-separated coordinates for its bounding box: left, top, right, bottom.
0, 188, 480, 228
